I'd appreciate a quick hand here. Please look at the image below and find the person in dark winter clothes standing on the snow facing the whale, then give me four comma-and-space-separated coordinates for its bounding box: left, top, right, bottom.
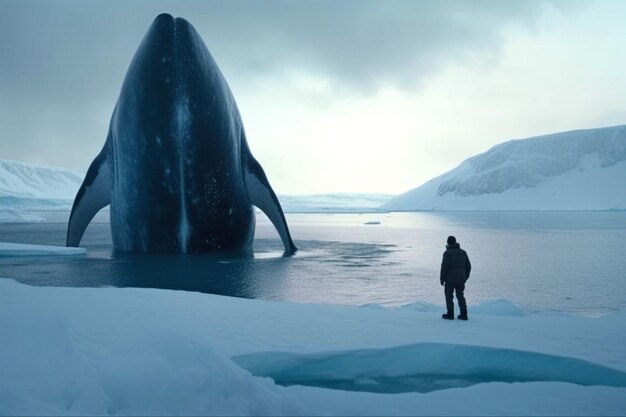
439, 236, 472, 320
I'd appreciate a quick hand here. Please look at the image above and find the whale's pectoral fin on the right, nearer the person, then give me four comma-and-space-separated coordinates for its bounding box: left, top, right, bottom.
243, 152, 298, 255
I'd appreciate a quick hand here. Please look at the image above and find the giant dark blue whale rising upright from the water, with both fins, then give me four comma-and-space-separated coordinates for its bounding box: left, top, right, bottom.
66, 14, 297, 255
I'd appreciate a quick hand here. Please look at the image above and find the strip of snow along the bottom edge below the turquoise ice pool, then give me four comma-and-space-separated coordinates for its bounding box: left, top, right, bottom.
290, 382, 626, 416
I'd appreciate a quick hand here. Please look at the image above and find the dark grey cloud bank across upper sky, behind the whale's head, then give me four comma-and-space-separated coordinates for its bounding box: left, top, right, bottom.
0, 0, 554, 172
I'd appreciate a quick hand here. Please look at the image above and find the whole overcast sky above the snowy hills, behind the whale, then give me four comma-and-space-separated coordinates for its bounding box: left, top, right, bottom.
0, 0, 626, 194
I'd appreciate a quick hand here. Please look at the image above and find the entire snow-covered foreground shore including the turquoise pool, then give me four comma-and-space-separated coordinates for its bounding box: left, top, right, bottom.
0, 279, 626, 415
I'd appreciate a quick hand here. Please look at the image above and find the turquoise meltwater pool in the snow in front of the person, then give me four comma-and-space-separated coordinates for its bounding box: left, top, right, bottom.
232, 343, 626, 393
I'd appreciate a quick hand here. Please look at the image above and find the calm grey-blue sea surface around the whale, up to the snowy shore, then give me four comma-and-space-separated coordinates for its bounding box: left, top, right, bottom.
0, 212, 626, 314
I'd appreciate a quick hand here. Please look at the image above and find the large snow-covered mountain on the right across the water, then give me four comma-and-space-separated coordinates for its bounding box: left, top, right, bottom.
382, 125, 626, 210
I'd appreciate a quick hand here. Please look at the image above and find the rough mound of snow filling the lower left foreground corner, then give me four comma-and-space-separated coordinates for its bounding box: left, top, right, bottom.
0, 315, 303, 415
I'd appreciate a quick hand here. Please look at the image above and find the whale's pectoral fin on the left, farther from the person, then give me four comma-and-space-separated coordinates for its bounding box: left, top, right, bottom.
66, 145, 111, 246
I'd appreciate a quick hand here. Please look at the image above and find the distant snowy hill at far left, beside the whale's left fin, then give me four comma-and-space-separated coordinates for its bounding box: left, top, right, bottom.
0, 160, 83, 209
